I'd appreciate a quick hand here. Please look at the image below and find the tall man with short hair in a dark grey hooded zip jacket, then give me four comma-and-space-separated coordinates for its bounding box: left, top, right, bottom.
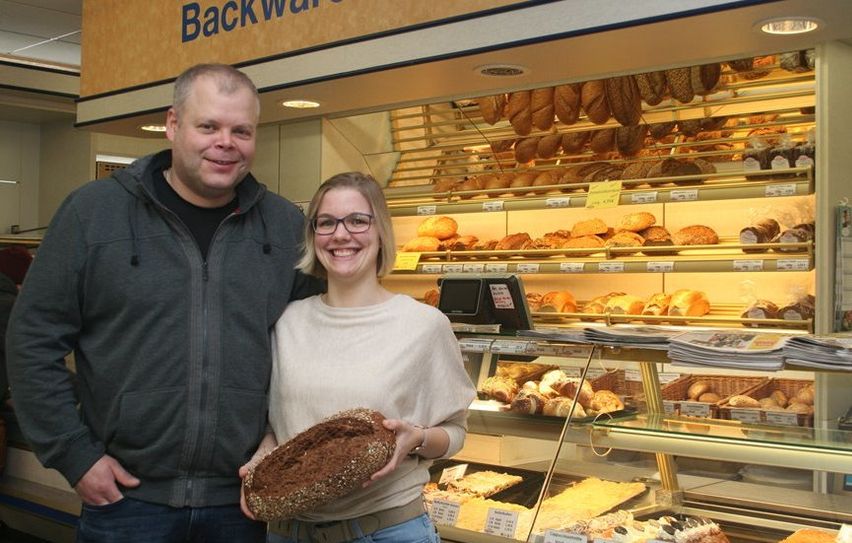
8, 65, 319, 543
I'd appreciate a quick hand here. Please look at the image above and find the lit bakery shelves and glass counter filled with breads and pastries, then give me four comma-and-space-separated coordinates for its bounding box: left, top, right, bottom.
385, 50, 852, 543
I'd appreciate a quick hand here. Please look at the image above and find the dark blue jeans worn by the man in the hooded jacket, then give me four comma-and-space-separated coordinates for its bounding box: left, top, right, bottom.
77, 498, 266, 543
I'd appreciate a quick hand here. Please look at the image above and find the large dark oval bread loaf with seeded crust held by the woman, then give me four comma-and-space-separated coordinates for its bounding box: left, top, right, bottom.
243, 408, 396, 522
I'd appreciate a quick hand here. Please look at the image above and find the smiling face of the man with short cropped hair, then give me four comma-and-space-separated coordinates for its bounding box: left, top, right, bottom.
166, 76, 258, 207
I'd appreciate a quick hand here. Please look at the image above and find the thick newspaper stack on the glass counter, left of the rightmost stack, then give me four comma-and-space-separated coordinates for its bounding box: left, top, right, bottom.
669, 330, 793, 371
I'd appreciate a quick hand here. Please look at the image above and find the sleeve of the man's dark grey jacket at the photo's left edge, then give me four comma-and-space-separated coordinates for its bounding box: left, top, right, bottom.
6, 194, 104, 486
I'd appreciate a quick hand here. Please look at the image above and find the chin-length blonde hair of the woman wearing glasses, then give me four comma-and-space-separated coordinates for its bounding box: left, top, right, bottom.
296, 172, 396, 278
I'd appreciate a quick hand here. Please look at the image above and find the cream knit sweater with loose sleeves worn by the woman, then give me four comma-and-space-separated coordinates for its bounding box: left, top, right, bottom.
269, 295, 476, 521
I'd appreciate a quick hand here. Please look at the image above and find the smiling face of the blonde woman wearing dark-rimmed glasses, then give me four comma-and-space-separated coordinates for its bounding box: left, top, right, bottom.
314, 187, 379, 283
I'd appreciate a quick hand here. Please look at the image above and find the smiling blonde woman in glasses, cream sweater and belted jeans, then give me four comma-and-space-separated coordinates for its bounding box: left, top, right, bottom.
241, 172, 475, 543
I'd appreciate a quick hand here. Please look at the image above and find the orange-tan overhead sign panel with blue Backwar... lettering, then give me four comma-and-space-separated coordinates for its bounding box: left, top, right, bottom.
80, 0, 524, 97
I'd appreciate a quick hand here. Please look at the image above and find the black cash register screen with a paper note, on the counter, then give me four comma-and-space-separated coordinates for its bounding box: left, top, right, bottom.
438, 274, 533, 334
